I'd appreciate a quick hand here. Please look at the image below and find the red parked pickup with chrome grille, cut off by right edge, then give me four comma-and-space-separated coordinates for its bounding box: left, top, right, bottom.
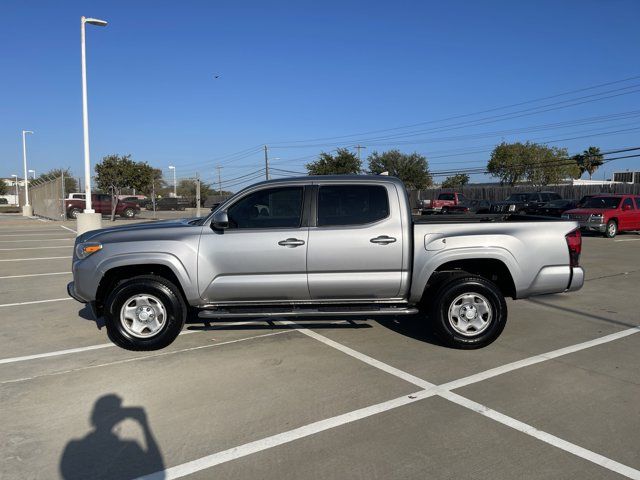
562, 195, 640, 238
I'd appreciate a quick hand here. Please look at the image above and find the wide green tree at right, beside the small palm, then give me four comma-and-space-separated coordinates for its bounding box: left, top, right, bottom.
487, 142, 579, 186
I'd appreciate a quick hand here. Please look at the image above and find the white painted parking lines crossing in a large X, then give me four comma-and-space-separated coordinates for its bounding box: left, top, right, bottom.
138, 321, 640, 480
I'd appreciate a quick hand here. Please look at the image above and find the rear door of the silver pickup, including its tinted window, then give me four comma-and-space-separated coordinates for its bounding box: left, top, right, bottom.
307, 182, 403, 300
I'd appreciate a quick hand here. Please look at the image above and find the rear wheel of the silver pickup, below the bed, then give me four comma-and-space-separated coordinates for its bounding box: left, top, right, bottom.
427, 275, 507, 349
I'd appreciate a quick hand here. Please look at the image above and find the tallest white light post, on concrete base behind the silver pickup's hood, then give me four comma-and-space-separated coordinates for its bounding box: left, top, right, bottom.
77, 16, 107, 235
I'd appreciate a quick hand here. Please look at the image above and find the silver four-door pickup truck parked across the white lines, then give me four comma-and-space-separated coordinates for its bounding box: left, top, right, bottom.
67, 176, 584, 350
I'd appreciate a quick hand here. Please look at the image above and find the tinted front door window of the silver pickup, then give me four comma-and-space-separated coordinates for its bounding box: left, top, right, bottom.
227, 187, 303, 228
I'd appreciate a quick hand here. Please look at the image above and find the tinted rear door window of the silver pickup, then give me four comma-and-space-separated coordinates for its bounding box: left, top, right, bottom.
318, 185, 389, 227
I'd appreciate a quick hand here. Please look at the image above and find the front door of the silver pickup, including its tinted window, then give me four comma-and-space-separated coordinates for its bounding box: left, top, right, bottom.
198, 185, 309, 303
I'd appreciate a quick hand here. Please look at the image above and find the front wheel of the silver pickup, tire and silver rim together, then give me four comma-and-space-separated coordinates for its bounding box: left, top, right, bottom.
104, 275, 187, 350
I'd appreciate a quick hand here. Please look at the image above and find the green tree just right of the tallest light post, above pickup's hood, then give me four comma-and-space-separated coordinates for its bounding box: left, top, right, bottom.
95, 155, 156, 222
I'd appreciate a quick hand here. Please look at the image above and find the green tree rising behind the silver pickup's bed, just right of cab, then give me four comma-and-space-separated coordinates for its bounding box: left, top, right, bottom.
368, 150, 433, 190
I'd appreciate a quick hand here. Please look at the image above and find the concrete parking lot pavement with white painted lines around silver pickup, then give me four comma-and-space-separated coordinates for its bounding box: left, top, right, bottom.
0, 215, 640, 479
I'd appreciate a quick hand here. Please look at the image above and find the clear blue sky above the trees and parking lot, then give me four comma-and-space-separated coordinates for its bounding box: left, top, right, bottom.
0, 0, 640, 190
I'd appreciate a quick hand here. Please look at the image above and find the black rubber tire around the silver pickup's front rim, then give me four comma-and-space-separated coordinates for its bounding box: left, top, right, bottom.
104, 275, 187, 351
